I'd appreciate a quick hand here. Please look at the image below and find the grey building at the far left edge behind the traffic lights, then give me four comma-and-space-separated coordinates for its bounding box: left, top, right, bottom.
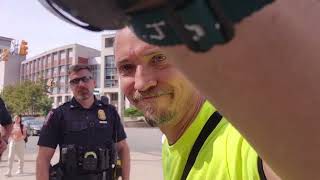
0, 36, 26, 92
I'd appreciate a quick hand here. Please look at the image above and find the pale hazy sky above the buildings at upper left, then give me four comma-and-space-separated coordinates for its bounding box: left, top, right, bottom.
0, 0, 111, 59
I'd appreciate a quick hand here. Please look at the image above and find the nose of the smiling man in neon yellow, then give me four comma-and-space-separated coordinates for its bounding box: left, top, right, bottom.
134, 66, 157, 91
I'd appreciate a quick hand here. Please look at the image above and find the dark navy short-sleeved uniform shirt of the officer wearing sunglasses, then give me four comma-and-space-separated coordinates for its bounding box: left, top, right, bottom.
38, 98, 127, 149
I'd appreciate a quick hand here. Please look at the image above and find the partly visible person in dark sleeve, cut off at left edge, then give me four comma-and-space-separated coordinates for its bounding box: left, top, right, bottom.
0, 98, 12, 158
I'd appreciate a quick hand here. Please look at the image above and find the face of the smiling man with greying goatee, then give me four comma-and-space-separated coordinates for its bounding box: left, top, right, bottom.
115, 30, 195, 125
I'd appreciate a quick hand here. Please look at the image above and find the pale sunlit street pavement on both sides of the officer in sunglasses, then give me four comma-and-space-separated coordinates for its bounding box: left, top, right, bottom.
0, 128, 163, 180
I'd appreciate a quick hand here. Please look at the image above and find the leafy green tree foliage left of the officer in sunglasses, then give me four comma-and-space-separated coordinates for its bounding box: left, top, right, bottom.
1, 81, 52, 115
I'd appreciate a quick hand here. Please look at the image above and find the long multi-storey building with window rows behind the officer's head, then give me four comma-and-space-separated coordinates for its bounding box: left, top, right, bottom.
20, 44, 100, 108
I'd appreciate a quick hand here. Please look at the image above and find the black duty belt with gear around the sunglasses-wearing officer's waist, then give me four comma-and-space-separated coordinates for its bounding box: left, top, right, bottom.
57, 144, 121, 180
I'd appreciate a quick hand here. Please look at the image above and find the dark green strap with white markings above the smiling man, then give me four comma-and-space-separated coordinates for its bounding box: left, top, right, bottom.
129, 0, 274, 51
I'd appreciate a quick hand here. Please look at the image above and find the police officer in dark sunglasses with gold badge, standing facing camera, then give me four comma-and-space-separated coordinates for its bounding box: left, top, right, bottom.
36, 65, 130, 180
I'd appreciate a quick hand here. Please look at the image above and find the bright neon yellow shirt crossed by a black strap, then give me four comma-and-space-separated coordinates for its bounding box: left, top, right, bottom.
162, 102, 260, 180
